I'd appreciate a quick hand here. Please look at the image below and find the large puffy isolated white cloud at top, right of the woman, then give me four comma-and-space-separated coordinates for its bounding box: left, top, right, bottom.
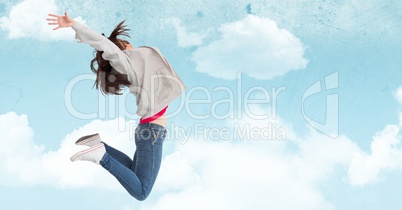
192, 15, 308, 80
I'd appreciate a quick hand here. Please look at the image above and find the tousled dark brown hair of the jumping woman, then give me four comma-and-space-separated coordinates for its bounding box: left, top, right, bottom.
91, 20, 131, 95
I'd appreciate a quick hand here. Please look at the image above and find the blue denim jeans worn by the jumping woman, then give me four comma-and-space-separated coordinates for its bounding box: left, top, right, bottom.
100, 123, 166, 201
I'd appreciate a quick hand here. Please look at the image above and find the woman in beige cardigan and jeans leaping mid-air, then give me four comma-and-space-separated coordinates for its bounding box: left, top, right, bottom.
47, 13, 186, 201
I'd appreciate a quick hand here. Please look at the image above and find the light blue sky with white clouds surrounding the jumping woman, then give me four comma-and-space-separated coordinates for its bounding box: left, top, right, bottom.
0, 0, 402, 209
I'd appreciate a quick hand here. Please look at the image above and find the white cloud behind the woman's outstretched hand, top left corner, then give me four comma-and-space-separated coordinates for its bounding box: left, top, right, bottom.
0, 0, 83, 41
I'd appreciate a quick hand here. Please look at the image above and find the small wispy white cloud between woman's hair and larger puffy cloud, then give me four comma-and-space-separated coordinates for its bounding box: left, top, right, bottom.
162, 18, 208, 47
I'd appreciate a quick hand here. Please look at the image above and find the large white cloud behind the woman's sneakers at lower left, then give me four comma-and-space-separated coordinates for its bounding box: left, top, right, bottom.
0, 112, 135, 191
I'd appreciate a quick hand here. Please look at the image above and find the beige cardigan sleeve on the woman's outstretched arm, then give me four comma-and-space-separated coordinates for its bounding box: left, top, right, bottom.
72, 21, 130, 74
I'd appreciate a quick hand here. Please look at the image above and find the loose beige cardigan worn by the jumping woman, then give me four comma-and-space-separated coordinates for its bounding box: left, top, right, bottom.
72, 21, 187, 118
